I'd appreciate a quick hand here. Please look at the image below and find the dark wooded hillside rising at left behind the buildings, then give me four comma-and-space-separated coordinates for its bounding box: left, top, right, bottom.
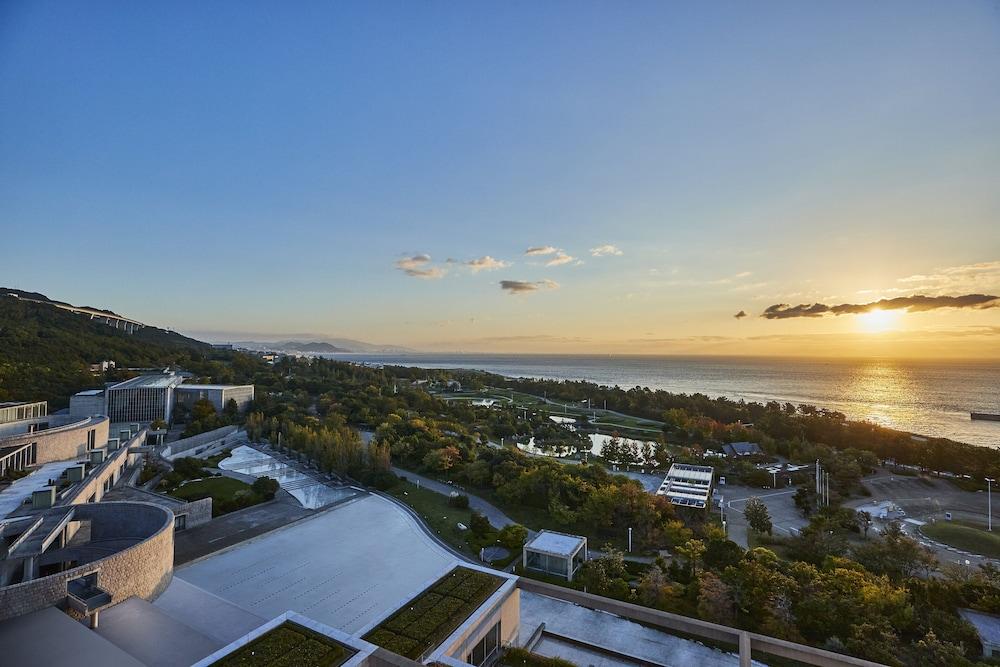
0, 290, 248, 410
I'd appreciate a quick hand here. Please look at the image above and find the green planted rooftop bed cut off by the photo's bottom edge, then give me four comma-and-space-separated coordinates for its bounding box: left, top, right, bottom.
212, 621, 354, 667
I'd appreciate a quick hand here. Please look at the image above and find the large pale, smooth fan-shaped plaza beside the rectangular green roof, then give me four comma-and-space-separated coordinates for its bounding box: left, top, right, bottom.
176, 495, 455, 634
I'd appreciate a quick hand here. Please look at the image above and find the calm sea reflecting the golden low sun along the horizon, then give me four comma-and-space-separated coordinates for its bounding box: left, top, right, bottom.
324, 354, 1000, 447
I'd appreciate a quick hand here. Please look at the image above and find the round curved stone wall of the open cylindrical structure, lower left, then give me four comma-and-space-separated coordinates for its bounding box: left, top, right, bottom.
0, 502, 174, 620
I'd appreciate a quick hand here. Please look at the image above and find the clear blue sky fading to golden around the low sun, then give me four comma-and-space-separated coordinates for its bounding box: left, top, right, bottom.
0, 0, 1000, 358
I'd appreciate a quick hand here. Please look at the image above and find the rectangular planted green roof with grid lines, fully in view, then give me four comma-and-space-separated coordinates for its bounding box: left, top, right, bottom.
364, 567, 503, 660
